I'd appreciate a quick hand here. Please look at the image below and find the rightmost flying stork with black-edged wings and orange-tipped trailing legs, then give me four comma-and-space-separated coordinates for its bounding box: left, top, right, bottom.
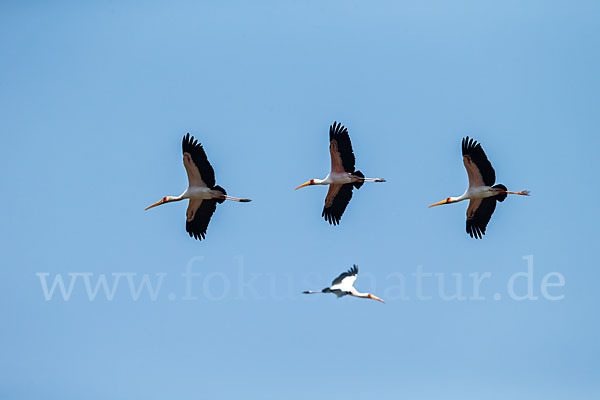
429, 136, 529, 239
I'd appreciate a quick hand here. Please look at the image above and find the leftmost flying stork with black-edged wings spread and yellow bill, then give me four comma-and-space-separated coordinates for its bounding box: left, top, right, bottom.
146, 133, 251, 240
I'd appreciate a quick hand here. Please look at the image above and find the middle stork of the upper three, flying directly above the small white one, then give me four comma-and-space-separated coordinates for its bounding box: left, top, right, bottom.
296, 122, 385, 225
